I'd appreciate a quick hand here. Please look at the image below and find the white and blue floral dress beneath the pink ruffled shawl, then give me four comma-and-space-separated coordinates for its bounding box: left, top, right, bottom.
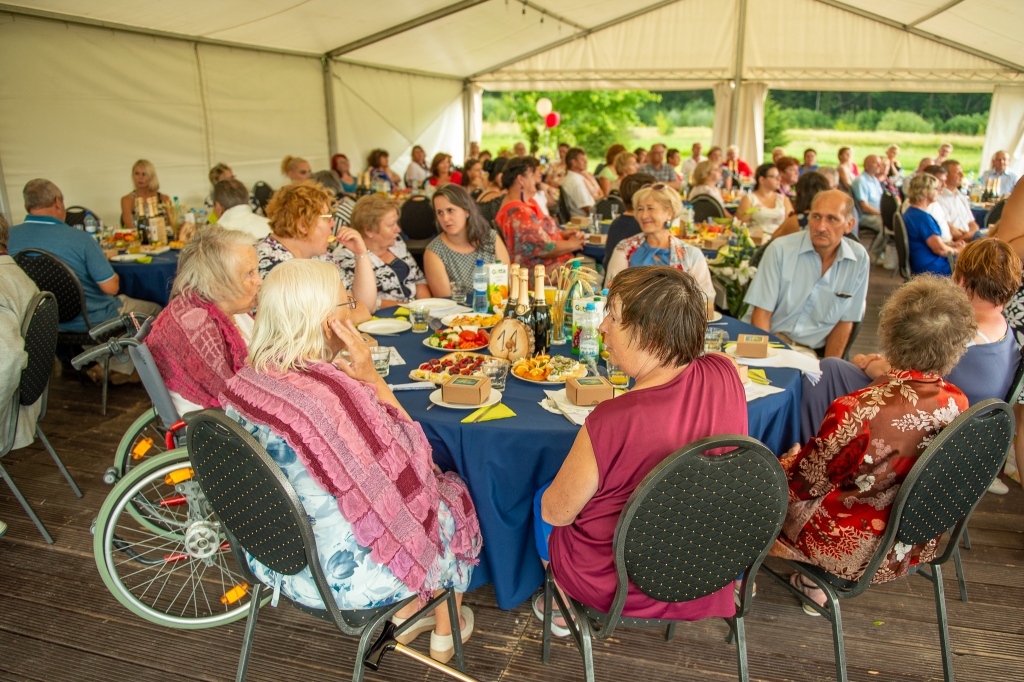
224, 406, 473, 610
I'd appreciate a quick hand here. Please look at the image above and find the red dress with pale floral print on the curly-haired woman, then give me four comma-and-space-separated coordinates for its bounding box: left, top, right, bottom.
772, 370, 968, 583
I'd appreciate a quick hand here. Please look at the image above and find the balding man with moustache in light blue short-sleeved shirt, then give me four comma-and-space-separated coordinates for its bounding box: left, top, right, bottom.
744, 189, 870, 357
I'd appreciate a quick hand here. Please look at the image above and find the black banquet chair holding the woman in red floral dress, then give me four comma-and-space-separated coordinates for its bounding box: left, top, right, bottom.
765, 399, 1014, 682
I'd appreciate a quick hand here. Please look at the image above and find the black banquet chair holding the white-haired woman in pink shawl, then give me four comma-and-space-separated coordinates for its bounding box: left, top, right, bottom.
186, 410, 472, 682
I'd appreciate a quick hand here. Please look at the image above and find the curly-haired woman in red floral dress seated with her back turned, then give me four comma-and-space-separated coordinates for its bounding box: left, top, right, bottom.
772, 275, 978, 615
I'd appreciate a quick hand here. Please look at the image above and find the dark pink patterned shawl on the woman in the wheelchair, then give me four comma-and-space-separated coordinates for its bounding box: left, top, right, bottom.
145, 293, 248, 409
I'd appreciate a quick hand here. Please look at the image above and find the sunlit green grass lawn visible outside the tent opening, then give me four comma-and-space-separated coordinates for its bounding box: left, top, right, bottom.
481, 123, 985, 172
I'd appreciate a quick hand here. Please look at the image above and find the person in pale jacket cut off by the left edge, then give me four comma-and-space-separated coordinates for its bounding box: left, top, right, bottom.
0, 213, 43, 462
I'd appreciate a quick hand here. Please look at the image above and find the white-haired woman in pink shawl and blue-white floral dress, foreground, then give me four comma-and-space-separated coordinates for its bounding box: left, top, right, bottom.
220, 259, 482, 663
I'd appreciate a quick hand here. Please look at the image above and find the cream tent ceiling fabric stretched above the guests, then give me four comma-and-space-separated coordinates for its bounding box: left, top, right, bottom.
6, 0, 1024, 91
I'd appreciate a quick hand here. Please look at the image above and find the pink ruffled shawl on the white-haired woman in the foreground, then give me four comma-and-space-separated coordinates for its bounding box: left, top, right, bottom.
220, 363, 482, 596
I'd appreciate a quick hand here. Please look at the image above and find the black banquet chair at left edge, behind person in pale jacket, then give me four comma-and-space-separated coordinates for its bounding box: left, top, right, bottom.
0, 291, 82, 545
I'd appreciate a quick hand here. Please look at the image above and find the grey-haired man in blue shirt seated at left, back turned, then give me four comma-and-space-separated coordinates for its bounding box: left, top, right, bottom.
9, 178, 161, 383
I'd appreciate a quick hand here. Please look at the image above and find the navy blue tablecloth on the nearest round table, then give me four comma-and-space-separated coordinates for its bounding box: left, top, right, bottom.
378, 310, 801, 609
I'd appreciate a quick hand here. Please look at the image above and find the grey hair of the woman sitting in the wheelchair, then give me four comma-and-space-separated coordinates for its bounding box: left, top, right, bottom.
171, 225, 254, 303
